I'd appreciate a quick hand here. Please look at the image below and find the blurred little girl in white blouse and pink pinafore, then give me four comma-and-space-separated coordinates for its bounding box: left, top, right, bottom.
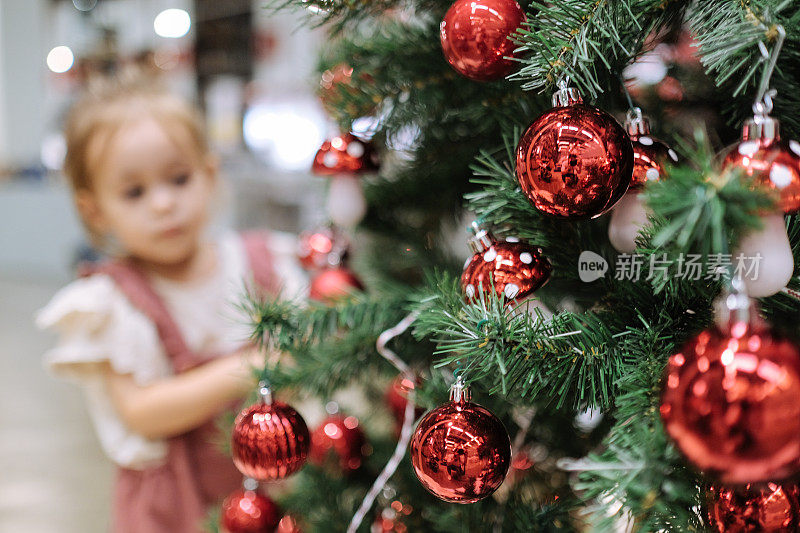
37, 76, 302, 533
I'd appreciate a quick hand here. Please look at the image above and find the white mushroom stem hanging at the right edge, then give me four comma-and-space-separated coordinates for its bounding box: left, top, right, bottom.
731, 213, 794, 298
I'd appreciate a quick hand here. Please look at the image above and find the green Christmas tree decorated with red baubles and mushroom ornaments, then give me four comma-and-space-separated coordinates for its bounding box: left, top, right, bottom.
222, 0, 800, 532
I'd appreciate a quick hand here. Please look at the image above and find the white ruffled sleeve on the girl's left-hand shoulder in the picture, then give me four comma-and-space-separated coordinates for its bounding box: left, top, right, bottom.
36, 274, 170, 385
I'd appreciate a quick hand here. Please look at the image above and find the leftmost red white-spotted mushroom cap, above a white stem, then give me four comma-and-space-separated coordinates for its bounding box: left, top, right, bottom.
311, 133, 378, 176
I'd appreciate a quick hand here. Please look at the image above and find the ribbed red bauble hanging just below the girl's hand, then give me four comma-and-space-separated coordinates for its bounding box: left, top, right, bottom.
231, 402, 311, 481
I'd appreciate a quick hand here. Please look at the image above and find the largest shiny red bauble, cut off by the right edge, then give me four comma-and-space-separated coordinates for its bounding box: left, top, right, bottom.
660, 322, 800, 484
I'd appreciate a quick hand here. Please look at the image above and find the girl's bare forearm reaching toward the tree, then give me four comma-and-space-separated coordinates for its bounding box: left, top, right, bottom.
106, 348, 264, 439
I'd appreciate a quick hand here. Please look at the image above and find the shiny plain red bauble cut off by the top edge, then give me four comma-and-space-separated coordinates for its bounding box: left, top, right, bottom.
439, 0, 525, 81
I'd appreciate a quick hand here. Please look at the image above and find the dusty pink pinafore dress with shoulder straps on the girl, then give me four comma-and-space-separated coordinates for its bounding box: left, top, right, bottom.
86, 233, 277, 533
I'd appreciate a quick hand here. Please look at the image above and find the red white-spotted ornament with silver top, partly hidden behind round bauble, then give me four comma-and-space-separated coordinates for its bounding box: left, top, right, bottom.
625, 107, 678, 188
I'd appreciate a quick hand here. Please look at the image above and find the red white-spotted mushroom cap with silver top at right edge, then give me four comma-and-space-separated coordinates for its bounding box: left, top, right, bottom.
722, 114, 800, 213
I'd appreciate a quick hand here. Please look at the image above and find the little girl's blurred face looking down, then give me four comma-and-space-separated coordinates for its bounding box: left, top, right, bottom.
79, 117, 215, 265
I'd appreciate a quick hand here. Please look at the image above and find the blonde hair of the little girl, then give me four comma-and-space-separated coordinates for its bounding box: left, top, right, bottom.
63, 71, 209, 244
